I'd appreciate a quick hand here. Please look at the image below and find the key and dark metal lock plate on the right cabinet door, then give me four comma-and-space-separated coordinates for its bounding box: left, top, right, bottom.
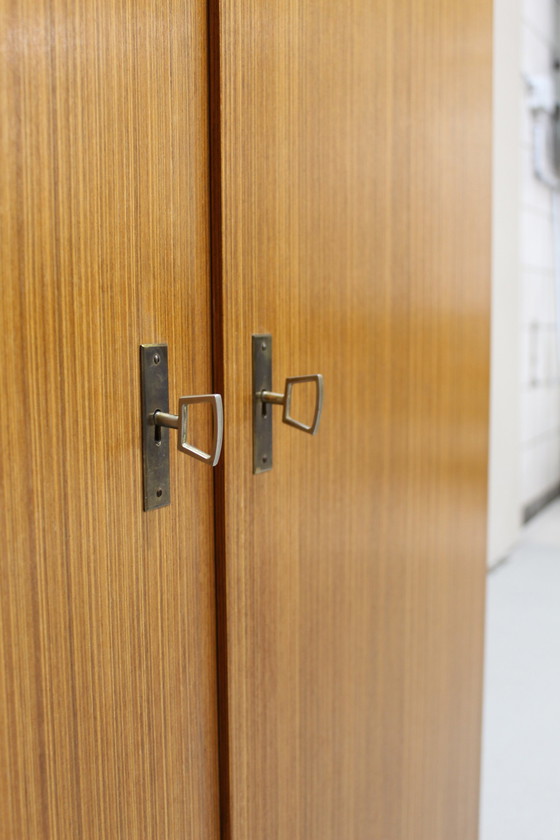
253, 334, 323, 473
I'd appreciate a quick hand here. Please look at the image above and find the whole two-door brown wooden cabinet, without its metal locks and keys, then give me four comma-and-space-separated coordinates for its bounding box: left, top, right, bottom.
0, 0, 492, 840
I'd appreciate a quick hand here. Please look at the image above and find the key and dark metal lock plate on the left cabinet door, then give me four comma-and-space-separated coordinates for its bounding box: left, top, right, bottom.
140, 344, 224, 510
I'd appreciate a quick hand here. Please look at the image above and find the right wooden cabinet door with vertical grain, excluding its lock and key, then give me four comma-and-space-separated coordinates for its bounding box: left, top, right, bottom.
211, 0, 492, 840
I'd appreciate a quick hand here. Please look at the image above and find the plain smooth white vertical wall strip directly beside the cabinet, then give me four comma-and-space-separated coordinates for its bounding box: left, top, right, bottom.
488, 0, 522, 564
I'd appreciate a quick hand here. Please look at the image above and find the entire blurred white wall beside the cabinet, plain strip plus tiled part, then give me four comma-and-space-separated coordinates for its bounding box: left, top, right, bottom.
488, 0, 560, 564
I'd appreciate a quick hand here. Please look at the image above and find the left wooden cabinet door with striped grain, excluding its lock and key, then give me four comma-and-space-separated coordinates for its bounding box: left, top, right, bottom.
0, 0, 219, 840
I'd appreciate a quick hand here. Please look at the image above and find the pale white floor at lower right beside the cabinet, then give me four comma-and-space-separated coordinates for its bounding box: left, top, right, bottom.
480, 502, 560, 840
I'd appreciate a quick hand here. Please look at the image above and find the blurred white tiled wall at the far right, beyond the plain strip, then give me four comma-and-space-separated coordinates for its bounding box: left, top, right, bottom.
520, 0, 560, 507
